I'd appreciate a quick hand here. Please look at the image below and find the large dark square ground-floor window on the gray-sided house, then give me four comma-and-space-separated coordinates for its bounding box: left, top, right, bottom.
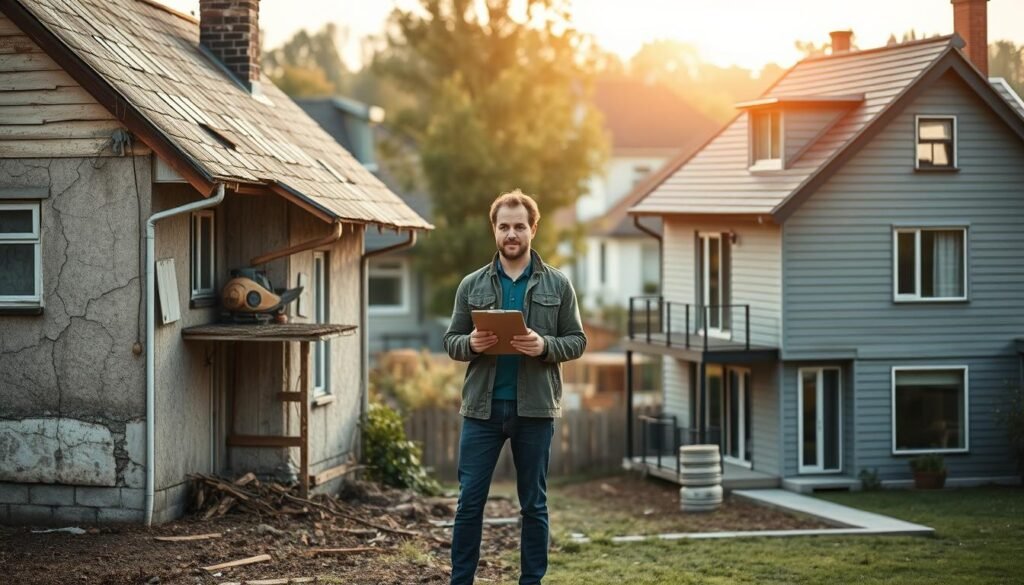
892, 366, 968, 454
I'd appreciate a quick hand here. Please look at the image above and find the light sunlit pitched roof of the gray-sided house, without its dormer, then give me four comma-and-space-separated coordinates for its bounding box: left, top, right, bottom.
630, 35, 1024, 221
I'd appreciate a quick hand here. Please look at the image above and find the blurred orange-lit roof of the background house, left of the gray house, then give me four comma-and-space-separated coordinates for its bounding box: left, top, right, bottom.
594, 79, 718, 151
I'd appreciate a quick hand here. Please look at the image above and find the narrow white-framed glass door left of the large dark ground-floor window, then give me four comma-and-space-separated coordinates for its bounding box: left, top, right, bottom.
797, 368, 843, 473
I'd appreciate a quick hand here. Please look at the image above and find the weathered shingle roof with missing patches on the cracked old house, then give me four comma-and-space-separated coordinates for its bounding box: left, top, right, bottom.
0, 0, 432, 228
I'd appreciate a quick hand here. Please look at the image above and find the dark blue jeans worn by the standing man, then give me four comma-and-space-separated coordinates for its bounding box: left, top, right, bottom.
452, 401, 555, 585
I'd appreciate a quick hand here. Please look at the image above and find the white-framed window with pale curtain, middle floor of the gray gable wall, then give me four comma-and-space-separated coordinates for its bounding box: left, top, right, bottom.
894, 227, 967, 301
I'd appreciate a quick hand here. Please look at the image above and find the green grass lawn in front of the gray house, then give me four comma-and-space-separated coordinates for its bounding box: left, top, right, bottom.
496, 486, 1024, 585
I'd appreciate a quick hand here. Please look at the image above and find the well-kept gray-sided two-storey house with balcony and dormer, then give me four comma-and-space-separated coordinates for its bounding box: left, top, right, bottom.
626, 0, 1024, 490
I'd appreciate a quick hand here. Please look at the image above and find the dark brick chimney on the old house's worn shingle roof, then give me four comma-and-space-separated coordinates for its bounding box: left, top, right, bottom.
199, 0, 259, 89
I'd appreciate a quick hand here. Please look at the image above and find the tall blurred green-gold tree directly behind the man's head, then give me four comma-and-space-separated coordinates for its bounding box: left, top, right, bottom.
374, 0, 607, 315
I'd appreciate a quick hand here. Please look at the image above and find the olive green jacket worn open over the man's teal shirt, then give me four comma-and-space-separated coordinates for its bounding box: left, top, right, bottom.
444, 251, 587, 419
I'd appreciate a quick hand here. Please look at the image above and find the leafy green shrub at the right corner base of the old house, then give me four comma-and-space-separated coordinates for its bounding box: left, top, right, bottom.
362, 404, 441, 496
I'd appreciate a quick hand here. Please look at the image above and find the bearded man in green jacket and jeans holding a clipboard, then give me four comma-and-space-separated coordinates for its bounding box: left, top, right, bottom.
444, 190, 587, 585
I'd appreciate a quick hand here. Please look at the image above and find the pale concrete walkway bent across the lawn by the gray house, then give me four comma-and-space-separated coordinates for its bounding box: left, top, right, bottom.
571, 490, 935, 543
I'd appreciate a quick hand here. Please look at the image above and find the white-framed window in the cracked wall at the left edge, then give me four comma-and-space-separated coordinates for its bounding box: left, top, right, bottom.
0, 203, 43, 306
